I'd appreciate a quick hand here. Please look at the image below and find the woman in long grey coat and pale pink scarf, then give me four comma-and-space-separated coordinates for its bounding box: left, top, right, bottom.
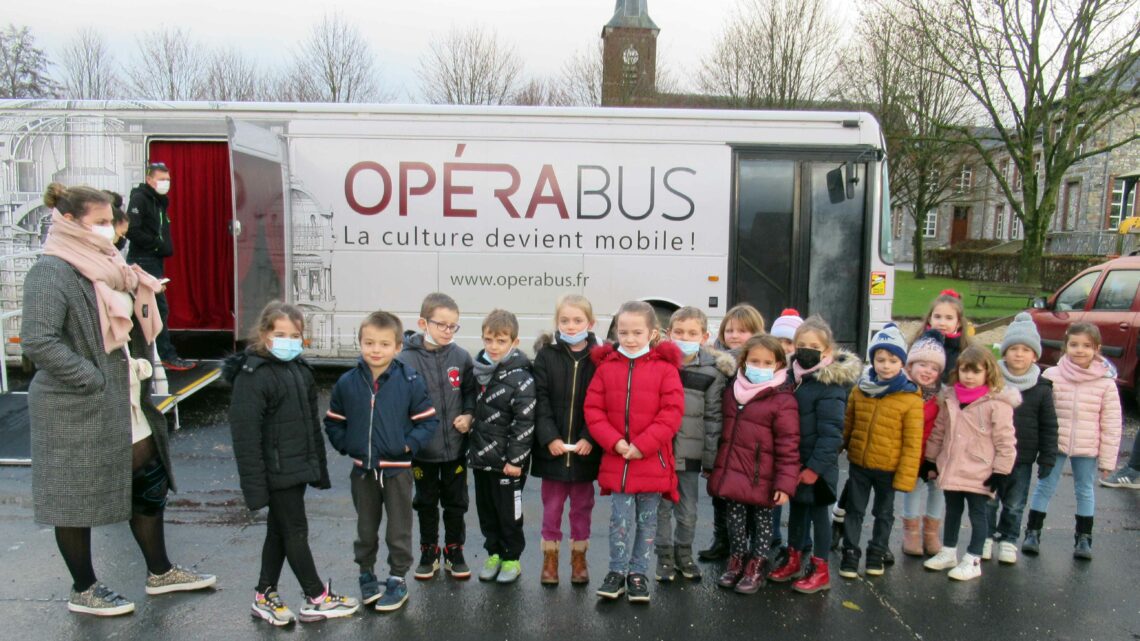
21, 182, 215, 616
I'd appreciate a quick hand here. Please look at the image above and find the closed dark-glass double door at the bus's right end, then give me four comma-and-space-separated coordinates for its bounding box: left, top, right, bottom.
730, 153, 871, 350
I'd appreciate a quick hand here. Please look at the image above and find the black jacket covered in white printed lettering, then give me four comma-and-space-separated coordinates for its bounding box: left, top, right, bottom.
467, 349, 538, 472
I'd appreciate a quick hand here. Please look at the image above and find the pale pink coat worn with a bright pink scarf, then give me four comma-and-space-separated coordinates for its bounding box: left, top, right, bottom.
926, 386, 1021, 497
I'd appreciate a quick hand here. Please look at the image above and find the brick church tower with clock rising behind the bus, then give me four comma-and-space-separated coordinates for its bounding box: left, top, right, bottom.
602, 0, 661, 106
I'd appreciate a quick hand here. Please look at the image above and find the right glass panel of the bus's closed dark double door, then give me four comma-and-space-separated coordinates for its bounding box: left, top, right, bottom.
807, 162, 866, 347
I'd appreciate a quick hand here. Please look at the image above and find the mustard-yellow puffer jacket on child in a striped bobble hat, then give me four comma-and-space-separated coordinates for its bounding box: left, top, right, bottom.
844, 387, 922, 492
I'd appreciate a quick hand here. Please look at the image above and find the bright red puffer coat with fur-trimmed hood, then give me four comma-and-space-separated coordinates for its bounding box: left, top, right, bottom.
585, 342, 685, 502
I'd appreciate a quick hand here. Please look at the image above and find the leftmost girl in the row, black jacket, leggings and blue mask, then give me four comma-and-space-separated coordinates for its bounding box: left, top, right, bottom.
226, 301, 360, 625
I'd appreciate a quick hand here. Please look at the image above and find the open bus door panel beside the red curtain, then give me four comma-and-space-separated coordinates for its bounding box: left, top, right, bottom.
226, 117, 290, 340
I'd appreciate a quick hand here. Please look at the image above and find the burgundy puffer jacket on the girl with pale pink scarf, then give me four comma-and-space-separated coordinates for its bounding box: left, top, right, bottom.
709, 374, 799, 508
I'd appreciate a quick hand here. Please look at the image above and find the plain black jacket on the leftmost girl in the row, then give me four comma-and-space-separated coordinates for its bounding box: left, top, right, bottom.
223, 349, 332, 510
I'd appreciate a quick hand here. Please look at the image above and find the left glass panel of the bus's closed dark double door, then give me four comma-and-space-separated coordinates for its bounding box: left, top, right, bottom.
732, 159, 796, 324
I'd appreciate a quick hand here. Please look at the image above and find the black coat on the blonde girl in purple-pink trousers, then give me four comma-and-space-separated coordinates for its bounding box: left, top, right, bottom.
531, 333, 602, 482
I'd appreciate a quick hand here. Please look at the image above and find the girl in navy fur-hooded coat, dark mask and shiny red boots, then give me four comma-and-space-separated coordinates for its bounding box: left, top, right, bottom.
768, 316, 863, 594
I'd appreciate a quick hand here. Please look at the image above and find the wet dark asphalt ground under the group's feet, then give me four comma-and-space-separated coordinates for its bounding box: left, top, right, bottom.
0, 372, 1140, 641
